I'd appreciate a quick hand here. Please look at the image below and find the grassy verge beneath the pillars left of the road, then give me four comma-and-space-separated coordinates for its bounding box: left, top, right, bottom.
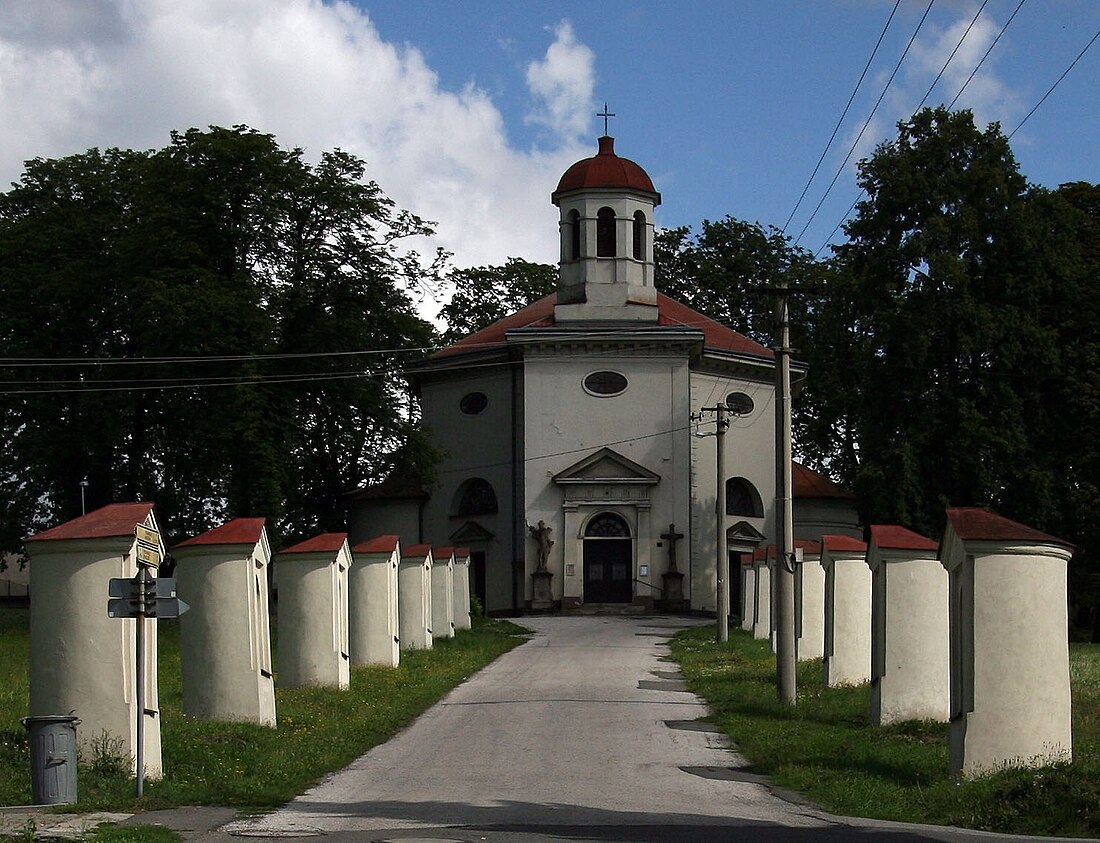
0, 606, 523, 811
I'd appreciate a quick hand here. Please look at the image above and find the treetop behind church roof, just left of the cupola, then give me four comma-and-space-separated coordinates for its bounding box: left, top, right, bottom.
439, 258, 558, 343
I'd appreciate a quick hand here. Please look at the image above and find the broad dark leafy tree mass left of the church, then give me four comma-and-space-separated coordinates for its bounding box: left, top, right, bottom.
0, 127, 443, 546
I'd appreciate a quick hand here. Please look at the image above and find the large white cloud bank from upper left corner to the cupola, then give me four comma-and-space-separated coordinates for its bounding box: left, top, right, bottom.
0, 0, 594, 283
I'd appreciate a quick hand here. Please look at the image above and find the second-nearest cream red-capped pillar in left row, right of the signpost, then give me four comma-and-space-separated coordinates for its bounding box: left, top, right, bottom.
172, 518, 275, 726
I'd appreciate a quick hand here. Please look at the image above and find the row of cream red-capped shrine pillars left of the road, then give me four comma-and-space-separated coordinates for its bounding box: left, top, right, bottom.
26, 503, 471, 778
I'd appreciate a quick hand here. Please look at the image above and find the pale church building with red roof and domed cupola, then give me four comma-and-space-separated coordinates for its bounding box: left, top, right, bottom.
349, 135, 805, 613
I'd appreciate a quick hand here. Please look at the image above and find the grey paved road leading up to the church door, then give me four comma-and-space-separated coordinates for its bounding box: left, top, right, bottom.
210, 616, 1069, 843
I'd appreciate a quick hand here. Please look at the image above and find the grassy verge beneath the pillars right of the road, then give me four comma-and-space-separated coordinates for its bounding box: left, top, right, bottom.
672, 626, 1100, 836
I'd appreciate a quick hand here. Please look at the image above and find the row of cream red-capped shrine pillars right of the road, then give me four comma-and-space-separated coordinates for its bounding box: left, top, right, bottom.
741, 507, 1073, 775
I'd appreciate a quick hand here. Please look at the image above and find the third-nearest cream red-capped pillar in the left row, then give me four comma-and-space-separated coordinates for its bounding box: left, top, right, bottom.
275, 533, 351, 689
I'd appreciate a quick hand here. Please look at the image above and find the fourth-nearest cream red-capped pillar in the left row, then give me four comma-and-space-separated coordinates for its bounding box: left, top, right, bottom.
348, 536, 402, 667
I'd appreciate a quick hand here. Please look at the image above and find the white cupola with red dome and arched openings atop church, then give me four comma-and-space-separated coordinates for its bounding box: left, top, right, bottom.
550, 135, 661, 324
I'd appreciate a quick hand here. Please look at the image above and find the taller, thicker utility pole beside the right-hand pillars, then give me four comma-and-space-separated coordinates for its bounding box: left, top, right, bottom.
776, 282, 798, 705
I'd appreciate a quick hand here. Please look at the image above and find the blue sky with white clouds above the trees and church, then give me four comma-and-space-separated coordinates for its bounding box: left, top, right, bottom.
0, 0, 1100, 312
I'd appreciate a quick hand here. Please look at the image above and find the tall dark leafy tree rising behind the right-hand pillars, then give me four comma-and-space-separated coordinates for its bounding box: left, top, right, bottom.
800, 108, 1071, 535
